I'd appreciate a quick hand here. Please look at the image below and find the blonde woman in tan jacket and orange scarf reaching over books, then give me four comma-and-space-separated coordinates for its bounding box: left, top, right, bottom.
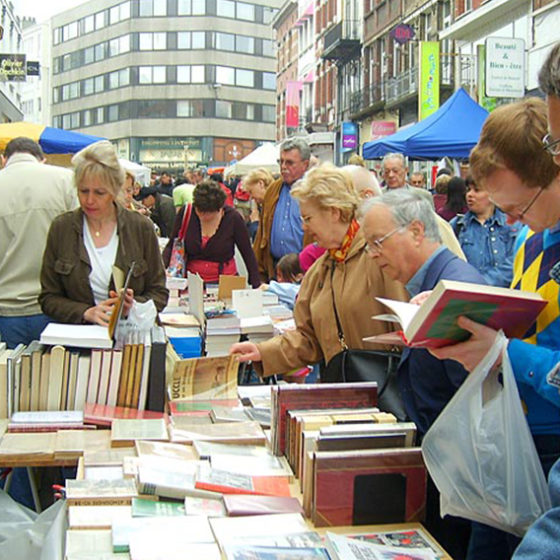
231, 164, 406, 376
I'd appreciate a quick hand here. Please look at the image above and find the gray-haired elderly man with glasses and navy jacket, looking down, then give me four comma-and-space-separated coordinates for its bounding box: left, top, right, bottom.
362, 190, 485, 559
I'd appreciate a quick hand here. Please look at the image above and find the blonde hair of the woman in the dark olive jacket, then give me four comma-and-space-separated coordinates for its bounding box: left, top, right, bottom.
72, 140, 125, 200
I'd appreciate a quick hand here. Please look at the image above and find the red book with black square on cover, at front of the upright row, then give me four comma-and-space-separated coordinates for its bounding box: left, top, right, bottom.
311, 448, 426, 527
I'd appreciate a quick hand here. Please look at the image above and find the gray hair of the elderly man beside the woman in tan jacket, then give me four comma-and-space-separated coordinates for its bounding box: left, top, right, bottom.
360, 189, 441, 243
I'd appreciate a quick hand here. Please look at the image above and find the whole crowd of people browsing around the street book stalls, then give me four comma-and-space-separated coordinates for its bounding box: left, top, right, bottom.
0, 39, 560, 560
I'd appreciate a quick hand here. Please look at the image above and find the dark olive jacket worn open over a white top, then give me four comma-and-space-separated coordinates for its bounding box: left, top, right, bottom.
39, 205, 169, 323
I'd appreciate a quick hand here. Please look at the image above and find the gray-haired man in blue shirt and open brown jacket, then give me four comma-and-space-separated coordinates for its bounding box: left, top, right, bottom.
253, 138, 312, 282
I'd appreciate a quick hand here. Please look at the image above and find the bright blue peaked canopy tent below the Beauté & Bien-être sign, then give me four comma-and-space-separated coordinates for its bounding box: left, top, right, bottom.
362, 88, 488, 160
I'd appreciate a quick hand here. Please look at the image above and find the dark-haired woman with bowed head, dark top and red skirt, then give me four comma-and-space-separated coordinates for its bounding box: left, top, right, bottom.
163, 179, 261, 288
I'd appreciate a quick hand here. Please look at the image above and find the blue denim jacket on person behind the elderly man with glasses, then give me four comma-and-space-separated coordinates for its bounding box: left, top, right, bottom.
449, 208, 521, 288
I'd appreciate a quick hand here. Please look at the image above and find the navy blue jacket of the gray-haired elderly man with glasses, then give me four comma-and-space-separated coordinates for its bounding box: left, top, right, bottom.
398, 249, 486, 437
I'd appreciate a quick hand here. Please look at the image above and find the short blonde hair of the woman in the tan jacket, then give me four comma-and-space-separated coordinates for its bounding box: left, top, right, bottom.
290, 163, 360, 223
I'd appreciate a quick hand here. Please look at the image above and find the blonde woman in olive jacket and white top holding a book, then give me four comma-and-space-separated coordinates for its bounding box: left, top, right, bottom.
39, 140, 169, 326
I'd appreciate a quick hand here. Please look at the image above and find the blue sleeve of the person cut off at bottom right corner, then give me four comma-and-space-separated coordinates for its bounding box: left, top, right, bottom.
513, 460, 560, 560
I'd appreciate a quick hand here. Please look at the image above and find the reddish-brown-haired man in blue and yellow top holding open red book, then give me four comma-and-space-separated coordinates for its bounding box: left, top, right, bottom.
434, 96, 560, 559
